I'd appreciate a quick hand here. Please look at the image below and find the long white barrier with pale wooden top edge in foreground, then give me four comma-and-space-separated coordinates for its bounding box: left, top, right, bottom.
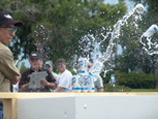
1, 93, 158, 119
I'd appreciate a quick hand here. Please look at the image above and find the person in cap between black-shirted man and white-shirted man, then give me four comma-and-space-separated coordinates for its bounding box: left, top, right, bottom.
44, 61, 58, 80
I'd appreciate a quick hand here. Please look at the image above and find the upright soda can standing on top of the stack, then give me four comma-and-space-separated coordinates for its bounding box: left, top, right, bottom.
78, 58, 87, 75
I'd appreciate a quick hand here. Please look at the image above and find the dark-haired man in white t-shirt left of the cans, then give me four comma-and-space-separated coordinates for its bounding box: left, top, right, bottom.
55, 59, 72, 92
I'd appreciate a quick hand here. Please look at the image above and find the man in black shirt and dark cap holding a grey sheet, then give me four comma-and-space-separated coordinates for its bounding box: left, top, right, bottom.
19, 52, 56, 92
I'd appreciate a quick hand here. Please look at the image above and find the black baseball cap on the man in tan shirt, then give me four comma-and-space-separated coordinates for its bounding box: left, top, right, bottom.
0, 11, 23, 26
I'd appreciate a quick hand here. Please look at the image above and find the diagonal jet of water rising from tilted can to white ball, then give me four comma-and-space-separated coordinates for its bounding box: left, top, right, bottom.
81, 4, 144, 75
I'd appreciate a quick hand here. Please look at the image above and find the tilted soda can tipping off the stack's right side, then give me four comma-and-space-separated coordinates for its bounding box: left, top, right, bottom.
89, 61, 103, 80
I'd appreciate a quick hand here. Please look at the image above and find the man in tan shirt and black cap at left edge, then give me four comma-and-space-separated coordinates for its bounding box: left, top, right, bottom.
0, 12, 23, 119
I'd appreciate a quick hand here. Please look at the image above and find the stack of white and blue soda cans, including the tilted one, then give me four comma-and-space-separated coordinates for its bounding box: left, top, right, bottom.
72, 58, 103, 92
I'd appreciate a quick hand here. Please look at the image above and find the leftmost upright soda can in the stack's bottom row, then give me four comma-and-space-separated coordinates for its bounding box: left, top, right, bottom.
72, 75, 82, 92
